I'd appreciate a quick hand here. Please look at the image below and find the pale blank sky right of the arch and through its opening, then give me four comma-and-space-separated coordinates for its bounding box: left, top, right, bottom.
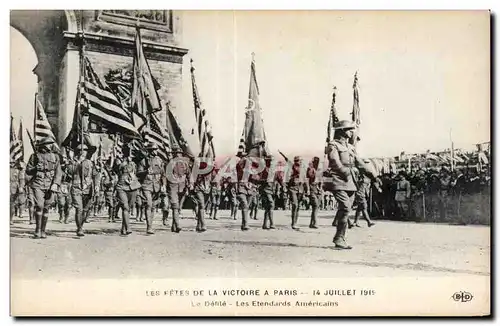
11, 11, 490, 162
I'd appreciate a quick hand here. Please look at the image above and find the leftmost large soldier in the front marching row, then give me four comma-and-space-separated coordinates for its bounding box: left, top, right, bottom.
26, 137, 62, 239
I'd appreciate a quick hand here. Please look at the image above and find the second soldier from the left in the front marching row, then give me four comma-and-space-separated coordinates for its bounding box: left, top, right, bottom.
68, 144, 99, 237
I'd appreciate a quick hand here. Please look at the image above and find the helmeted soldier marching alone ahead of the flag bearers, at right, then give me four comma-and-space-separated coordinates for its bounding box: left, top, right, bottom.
325, 120, 376, 249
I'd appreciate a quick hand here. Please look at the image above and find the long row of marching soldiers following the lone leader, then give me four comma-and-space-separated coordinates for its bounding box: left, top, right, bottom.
11, 138, 342, 238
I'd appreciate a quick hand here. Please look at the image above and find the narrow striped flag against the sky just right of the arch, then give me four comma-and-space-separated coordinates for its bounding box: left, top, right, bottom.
191, 59, 215, 158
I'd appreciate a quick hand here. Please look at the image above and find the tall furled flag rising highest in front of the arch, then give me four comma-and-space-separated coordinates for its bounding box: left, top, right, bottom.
130, 27, 162, 127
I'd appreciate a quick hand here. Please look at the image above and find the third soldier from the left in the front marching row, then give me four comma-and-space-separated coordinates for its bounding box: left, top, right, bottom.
113, 146, 141, 236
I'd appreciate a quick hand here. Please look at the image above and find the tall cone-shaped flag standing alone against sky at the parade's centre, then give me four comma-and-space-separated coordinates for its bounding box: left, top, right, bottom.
236, 54, 269, 157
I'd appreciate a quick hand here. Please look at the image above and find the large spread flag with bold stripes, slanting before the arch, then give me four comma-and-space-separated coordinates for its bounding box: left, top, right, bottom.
79, 57, 139, 136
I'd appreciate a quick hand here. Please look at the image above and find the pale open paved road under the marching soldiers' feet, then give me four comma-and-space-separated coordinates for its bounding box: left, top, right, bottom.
11, 211, 490, 279
